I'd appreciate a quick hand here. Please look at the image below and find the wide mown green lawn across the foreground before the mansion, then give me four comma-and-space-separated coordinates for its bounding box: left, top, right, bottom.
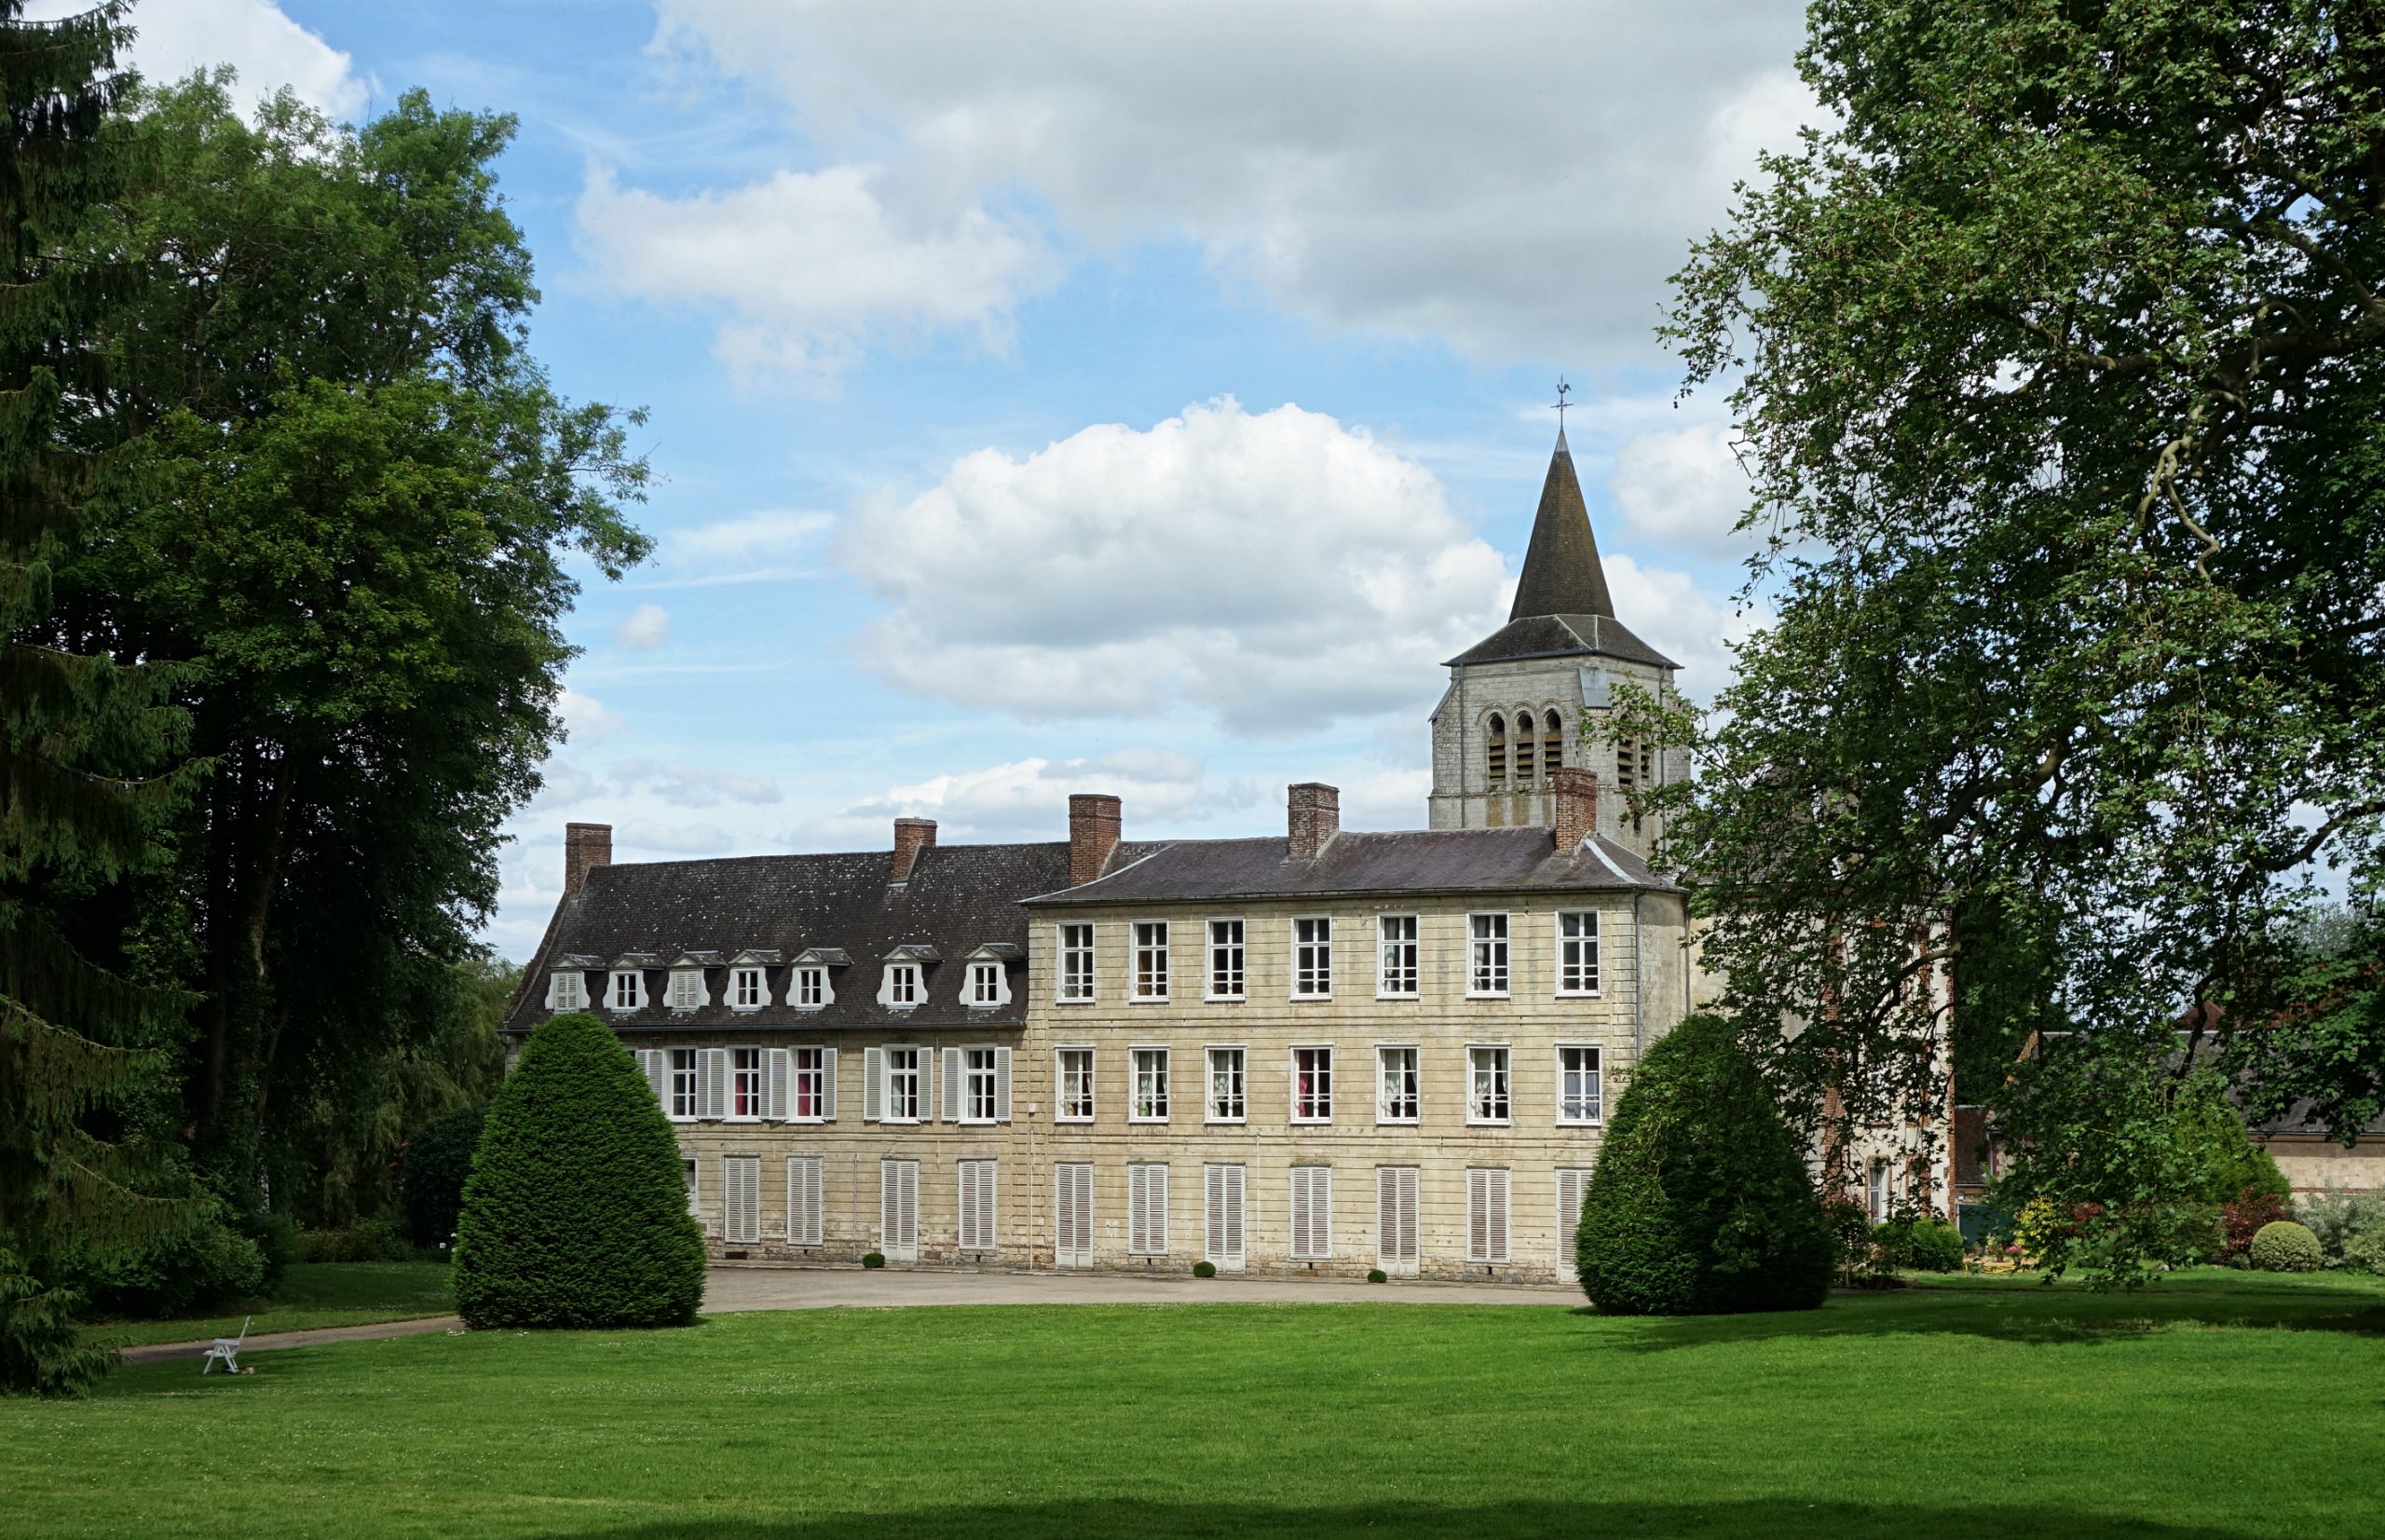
14, 1275, 2385, 1540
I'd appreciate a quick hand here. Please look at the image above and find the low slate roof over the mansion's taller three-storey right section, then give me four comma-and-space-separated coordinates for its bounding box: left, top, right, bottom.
1028, 827, 1677, 908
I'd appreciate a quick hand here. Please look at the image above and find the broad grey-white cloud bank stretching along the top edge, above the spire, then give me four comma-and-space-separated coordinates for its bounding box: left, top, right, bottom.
656, 0, 1813, 367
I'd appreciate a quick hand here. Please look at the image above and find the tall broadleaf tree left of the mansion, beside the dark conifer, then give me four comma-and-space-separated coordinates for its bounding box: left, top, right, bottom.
53, 76, 647, 1223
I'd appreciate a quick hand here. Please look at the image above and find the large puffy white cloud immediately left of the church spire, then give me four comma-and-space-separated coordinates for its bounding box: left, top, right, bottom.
842, 401, 1507, 734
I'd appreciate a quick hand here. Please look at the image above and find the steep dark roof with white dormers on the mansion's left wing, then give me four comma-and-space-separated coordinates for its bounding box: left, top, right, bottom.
506, 841, 1150, 1032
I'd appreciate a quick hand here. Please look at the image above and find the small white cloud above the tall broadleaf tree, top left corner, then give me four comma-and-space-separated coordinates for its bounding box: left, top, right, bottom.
26, 0, 370, 119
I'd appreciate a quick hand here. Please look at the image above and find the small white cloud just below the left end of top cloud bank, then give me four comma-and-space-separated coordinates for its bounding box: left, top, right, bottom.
578, 165, 1052, 379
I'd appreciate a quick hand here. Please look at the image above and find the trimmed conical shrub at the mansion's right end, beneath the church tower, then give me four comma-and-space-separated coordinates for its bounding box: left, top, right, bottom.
1574, 1015, 1832, 1315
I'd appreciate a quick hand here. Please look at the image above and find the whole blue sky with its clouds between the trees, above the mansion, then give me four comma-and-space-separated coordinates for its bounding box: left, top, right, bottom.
88, 0, 1810, 956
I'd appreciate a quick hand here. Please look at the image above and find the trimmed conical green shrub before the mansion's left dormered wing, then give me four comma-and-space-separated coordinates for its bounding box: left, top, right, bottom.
456, 1011, 703, 1326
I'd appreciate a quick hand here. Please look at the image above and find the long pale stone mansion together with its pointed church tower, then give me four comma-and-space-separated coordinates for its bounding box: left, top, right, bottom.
508, 434, 1696, 1278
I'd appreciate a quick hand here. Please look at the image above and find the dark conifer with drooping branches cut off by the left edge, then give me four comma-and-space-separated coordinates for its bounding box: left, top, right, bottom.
0, 0, 196, 1392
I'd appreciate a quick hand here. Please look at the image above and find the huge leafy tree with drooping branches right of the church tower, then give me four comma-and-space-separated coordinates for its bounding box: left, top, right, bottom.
1615, 0, 2385, 1273
